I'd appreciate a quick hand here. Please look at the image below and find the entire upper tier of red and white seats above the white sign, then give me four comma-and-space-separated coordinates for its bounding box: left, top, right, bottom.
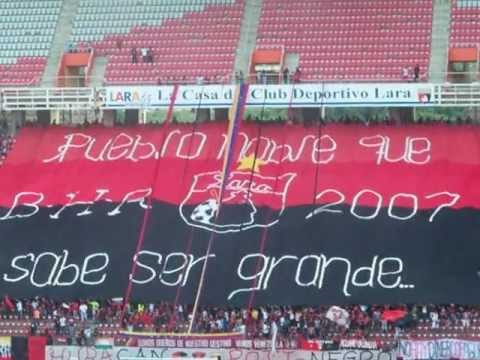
0, 0, 480, 86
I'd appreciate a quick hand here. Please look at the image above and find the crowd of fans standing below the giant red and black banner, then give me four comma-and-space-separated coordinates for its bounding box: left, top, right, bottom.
0, 296, 480, 344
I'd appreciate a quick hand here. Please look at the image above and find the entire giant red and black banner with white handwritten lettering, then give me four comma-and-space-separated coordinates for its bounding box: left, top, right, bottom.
0, 123, 480, 306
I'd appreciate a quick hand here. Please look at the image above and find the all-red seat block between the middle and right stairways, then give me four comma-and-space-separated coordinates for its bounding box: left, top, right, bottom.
257, 0, 432, 80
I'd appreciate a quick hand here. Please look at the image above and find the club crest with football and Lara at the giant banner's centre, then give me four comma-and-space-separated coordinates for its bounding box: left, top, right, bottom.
179, 171, 296, 234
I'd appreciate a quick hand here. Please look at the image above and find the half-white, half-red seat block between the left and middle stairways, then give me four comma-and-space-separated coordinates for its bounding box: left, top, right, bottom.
72, 0, 244, 84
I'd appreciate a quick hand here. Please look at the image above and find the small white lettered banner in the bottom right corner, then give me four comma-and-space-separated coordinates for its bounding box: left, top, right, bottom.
398, 339, 480, 360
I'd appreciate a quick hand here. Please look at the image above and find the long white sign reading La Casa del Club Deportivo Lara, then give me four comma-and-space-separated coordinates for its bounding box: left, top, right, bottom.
104, 83, 434, 108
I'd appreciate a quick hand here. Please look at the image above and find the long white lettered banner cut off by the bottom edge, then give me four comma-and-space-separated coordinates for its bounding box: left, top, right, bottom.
45, 346, 396, 360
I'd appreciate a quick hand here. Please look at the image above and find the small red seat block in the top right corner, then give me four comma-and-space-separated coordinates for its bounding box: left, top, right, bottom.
450, 0, 480, 47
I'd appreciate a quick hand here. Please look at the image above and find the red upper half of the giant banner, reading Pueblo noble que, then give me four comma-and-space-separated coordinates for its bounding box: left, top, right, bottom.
0, 123, 480, 210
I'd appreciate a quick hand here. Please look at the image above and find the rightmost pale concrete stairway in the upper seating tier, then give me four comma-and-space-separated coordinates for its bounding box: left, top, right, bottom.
428, 0, 452, 83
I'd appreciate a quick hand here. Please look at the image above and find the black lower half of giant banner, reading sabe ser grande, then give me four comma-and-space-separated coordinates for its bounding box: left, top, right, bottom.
0, 203, 480, 305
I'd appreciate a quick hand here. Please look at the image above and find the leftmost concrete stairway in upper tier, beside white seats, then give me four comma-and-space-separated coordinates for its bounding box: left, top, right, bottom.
42, 0, 79, 87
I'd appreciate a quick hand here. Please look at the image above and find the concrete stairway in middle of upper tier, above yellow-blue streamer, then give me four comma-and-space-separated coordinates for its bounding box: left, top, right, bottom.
235, 0, 263, 75
